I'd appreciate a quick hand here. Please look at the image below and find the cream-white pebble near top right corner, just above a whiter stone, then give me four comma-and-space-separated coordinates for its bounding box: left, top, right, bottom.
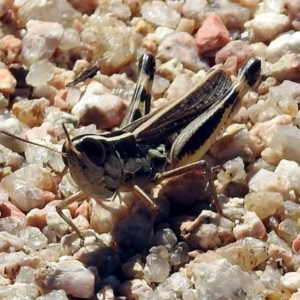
245, 12, 290, 43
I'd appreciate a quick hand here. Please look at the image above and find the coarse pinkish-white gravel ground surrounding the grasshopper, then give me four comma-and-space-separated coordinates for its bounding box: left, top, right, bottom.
0, 0, 300, 300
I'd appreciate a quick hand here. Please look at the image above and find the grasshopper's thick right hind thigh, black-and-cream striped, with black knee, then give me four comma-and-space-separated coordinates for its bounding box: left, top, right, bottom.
170, 59, 261, 167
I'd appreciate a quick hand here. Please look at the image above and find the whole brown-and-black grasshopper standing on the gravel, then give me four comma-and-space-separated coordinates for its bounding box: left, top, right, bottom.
0, 53, 261, 251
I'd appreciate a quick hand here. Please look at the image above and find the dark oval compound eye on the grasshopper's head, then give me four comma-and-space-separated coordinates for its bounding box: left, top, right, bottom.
76, 138, 106, 166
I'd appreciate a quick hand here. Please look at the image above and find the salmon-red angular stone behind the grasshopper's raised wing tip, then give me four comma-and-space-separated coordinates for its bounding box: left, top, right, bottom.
195, 13, 230, 54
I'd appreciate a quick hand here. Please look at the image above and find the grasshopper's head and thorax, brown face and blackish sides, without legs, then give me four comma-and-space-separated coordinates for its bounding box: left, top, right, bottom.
63, 131, 165, 200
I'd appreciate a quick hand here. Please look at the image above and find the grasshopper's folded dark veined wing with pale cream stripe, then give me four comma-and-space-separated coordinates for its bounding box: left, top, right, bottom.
132, 69, 232, 144
